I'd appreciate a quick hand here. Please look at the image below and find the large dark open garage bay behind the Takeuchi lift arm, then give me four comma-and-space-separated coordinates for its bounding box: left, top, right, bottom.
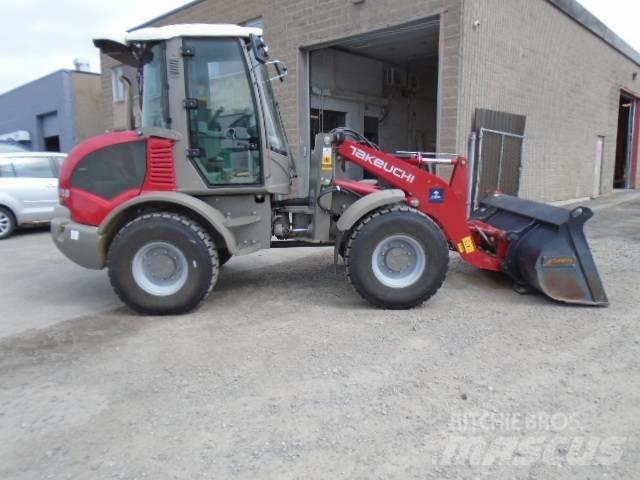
308, 17, 440, 177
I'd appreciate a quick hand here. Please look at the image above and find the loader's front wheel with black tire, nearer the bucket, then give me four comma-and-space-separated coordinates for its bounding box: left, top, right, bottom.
345, 206, 449, 310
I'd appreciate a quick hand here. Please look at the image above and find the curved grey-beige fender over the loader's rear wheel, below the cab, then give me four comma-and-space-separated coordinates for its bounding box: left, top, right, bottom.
98, 191, 238, 255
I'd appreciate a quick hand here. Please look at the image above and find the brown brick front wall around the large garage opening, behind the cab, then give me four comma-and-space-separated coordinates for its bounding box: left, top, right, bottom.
102, 0, 462, 152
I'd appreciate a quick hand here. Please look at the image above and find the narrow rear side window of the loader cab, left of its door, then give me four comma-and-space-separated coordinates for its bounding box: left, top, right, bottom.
139, 43, 169, 128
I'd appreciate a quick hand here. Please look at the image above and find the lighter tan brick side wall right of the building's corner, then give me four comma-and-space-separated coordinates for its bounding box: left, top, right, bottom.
458, 0, 640, 201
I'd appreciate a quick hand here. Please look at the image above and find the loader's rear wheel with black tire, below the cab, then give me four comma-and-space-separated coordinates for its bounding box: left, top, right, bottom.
107, 212, 219, 315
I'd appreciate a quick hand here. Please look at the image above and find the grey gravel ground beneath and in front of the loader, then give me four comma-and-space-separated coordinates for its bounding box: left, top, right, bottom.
0, 193, 640, 480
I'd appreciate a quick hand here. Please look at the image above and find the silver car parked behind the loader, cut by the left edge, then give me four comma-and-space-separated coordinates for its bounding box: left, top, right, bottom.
0, 152, 66, 240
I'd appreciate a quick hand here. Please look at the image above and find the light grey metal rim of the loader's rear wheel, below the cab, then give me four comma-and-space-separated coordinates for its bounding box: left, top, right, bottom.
131, 242, 189, 297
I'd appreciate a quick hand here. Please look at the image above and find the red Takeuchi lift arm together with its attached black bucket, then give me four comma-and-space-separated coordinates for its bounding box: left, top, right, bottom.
334, 131, 609, 306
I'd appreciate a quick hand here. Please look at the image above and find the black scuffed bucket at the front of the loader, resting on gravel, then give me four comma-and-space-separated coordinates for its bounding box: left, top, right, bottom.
472, 194, 609, 306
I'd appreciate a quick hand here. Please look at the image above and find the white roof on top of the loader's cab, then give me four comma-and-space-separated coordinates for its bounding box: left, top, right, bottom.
94, 23, 262, 46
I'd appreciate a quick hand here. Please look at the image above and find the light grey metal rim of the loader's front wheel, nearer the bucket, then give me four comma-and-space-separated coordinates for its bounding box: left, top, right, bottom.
371, 235, 427, 288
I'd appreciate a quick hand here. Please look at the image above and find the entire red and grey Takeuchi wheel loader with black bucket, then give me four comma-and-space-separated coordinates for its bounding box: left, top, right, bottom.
51, 24, 608, 314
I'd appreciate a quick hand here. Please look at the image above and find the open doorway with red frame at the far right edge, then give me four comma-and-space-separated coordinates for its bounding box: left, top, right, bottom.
613, 93, 640, 189
